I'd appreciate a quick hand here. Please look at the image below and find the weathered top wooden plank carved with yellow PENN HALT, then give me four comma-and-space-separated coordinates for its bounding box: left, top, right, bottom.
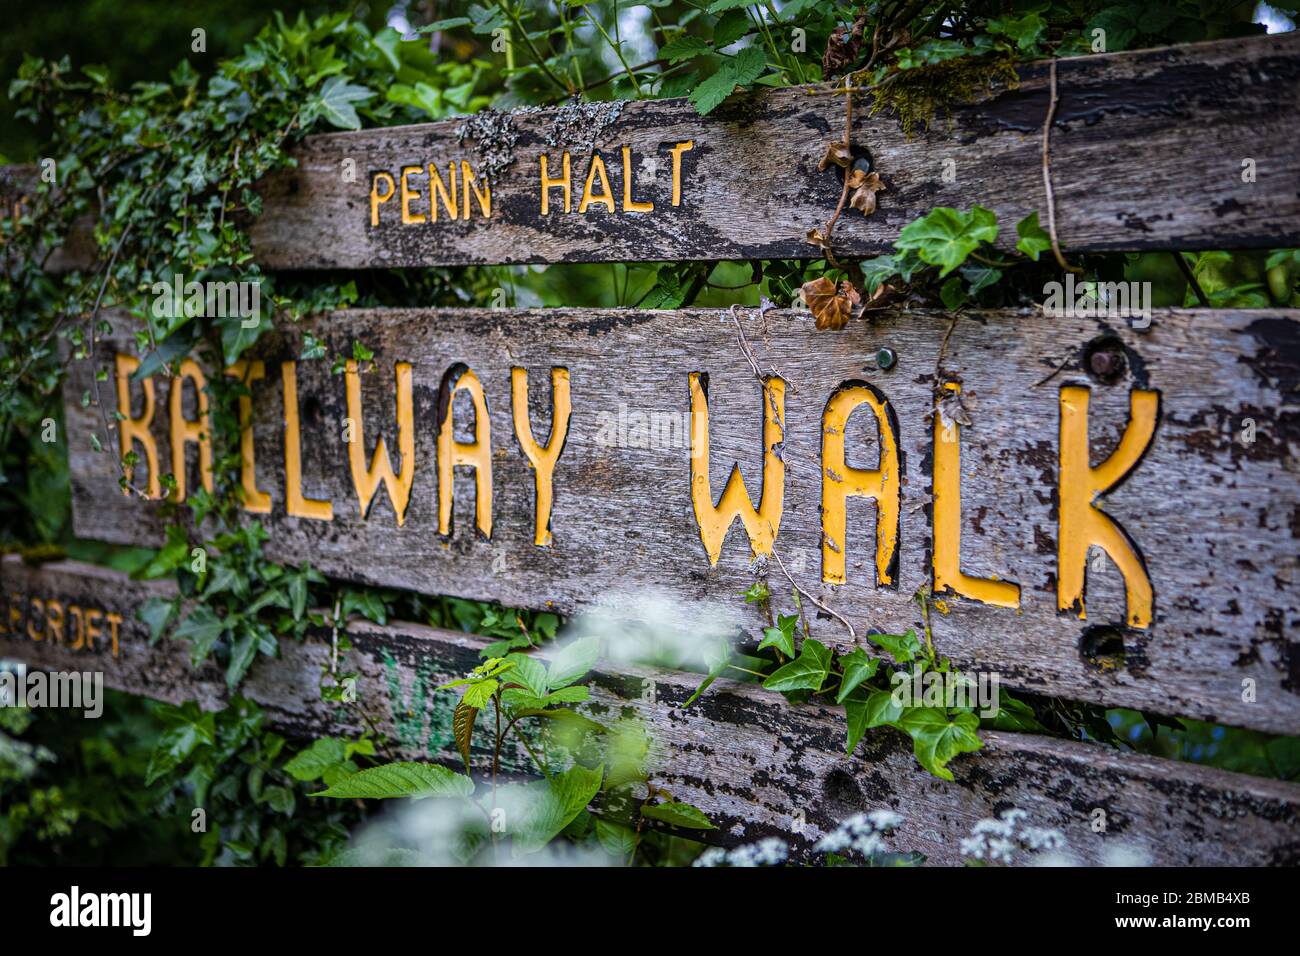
7, 33, 1300, 269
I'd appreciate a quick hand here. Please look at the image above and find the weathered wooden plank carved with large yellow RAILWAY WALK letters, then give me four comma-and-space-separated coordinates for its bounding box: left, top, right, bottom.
65, 310, 1300, 734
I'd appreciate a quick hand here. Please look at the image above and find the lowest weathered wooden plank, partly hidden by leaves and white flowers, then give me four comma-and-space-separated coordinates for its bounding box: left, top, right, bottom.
0, 557, 1300, 866
